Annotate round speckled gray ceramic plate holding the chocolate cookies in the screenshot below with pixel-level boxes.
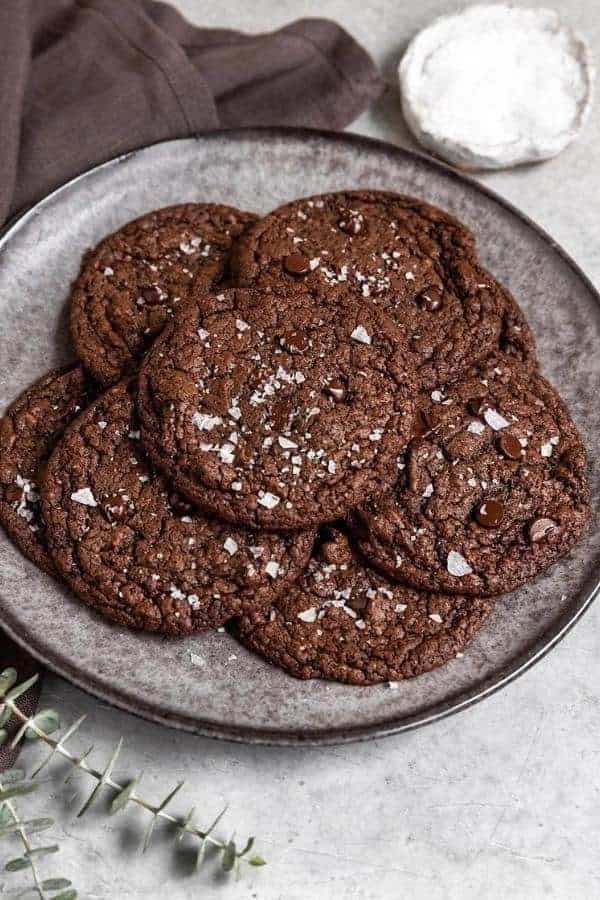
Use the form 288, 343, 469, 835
0, 129, 600, 744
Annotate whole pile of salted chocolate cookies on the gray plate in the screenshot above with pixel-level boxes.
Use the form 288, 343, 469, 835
0, 191, 589, 684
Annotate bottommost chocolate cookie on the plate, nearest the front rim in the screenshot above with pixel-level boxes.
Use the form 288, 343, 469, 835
233, 533, 493, 684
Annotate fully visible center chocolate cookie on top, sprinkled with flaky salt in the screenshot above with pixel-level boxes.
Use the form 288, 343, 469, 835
139, 288, 414, 529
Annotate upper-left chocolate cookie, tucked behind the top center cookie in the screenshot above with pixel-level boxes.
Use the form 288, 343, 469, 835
71, 203, 256, 385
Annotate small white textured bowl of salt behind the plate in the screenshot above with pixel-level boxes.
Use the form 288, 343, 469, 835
399, 5, 594, 169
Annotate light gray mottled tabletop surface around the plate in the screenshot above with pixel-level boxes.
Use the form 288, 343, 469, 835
8, 0, 600, 900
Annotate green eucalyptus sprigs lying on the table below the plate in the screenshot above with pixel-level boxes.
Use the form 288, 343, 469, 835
0, 669, 265, 888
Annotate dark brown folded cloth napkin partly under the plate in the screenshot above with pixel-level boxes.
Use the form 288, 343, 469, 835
0, 0, 383, 771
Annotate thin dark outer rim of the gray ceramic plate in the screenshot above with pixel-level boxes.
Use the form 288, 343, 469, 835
0, 126, 600, 747
